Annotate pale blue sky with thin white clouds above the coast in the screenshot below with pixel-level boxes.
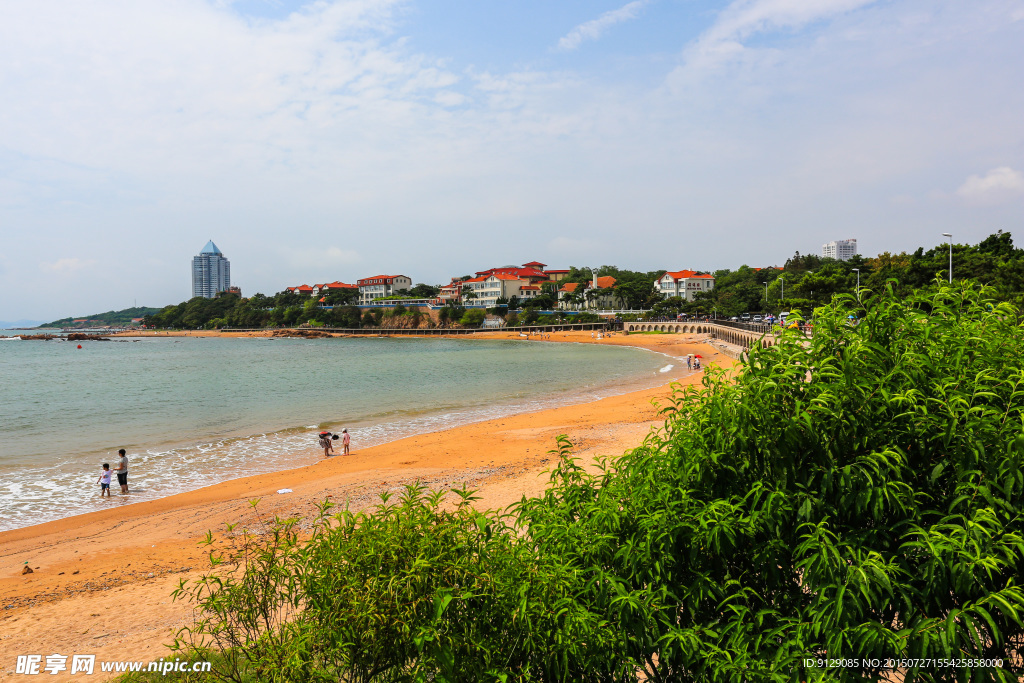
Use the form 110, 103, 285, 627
0, 0, 1024, 321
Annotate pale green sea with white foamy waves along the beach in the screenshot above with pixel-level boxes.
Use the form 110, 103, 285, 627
0, 332, 673, 529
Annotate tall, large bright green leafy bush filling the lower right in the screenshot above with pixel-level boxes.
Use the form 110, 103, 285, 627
519, 284, 1024, 681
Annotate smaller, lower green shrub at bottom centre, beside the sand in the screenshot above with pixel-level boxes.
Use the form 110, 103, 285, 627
175, 486, 610, 682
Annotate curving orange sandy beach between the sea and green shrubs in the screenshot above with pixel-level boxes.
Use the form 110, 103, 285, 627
0, 332, 734, 681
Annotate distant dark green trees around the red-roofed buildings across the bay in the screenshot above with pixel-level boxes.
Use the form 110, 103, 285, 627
143, 230, 1024, 329
